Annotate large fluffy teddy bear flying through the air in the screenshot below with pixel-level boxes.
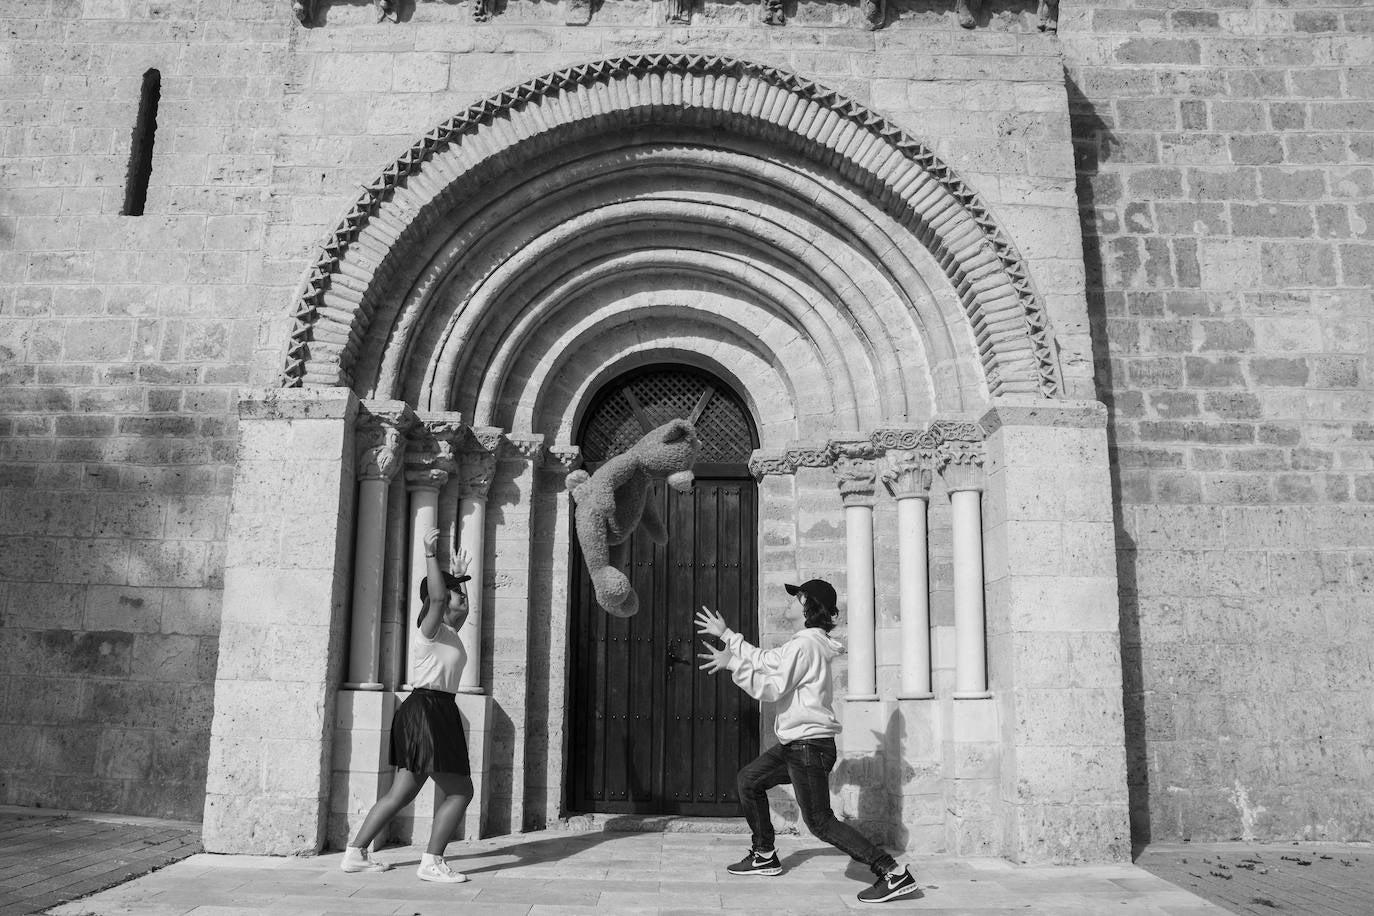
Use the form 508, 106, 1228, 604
566, 420, 701, 617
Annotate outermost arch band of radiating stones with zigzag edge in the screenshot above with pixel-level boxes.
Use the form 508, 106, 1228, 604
280, 54, 1062, 397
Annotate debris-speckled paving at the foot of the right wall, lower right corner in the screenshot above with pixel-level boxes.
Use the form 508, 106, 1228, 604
1136, 842, 1374, 916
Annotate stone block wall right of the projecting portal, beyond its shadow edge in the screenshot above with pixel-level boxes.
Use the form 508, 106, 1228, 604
1061, 0, 1374, 840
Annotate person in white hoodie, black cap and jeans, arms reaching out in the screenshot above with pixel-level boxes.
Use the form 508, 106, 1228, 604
697, 580, 919, 904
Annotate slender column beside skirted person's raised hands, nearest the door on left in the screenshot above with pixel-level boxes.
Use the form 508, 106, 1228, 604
458, 427, 502, 694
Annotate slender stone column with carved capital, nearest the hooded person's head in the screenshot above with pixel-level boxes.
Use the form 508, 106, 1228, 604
834, 449, 878, 702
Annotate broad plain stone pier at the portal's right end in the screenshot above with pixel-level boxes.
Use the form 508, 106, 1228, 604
981, 398, 1131, 862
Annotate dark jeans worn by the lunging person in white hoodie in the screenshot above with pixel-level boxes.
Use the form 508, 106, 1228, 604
738, 737, 897, 878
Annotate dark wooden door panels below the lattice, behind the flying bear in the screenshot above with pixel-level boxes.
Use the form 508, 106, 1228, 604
567, 365, 758, 816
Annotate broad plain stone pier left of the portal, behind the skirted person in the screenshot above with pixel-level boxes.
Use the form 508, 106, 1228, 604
202, 389, 359, 856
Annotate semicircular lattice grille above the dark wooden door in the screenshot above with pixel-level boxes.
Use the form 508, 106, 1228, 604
583, 369, 754, 464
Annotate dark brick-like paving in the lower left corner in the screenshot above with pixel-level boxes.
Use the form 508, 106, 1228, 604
0, 806, 201, 916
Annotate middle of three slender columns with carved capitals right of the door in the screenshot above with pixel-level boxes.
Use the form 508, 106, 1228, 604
882, 449, 934, 700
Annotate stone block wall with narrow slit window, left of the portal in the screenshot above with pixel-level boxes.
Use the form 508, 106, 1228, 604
0, 0, 294, 818
